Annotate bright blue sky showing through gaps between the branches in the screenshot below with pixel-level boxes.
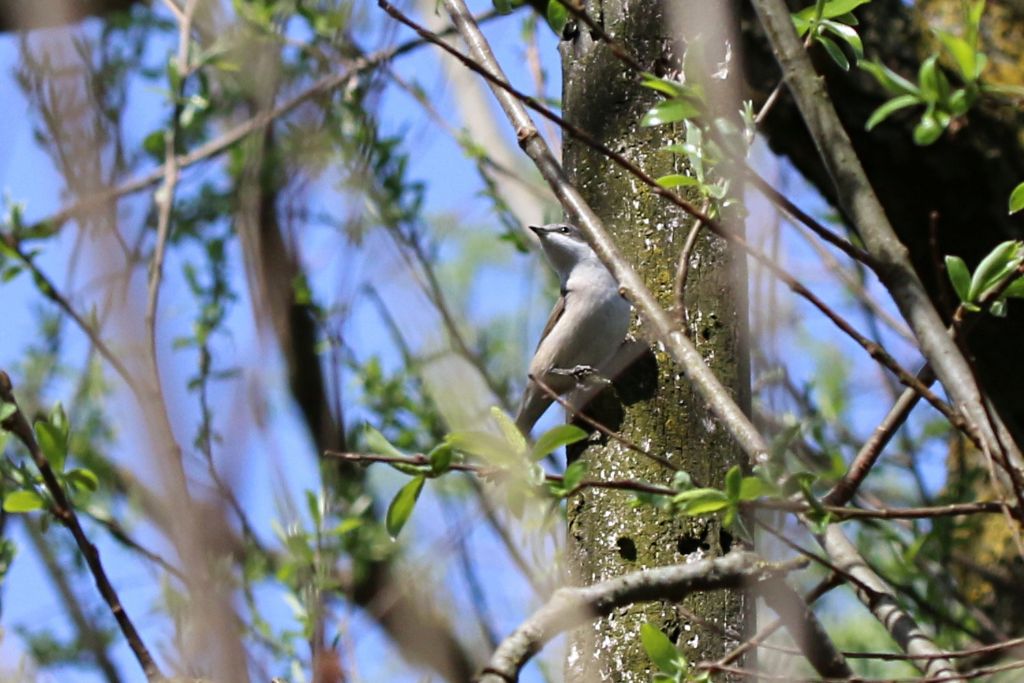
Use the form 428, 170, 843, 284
0, 3, 558, 681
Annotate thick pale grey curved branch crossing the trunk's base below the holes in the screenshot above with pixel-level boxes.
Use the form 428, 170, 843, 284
478, 551, 803, 683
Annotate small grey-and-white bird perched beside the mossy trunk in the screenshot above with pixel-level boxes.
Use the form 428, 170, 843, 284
515, 223, 632, 436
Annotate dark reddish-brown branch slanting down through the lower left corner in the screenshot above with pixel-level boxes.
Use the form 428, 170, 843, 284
0, 370, 164, 681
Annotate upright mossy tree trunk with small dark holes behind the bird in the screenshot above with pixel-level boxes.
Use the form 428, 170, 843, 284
561, 0, 753, 681
